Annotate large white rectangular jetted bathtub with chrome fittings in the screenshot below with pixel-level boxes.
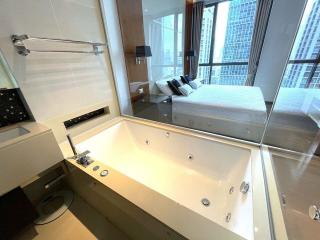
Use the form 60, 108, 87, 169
65, 119, 269, 239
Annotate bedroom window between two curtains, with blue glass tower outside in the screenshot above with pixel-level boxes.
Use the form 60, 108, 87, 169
198, 0, 256, 85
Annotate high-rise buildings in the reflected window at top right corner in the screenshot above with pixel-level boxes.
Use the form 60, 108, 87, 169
281, 1, 320, 88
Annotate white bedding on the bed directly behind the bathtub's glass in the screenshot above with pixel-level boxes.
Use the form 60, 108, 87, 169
172, 85, 267, 125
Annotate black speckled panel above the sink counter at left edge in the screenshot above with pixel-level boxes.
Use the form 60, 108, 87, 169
0, 89, 30, 128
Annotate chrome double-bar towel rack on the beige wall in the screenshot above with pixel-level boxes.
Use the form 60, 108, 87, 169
11, 34, 107, 56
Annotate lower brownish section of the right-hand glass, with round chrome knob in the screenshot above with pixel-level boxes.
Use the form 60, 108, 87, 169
270, 150, 320, 240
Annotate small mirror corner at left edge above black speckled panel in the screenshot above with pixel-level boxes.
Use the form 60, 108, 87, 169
0, 50, 18, 89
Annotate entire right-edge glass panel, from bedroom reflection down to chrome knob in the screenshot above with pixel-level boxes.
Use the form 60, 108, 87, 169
263, 0, 320, 240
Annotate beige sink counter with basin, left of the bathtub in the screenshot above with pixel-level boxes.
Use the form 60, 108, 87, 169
0, 122, 63, 196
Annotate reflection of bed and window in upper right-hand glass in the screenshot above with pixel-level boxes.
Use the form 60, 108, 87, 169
264, 0, 320, 154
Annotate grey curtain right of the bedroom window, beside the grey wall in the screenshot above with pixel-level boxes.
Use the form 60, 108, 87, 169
245, 0, 273, 86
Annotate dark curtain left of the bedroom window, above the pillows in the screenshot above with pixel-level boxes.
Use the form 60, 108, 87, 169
189, 2, 204, 79
